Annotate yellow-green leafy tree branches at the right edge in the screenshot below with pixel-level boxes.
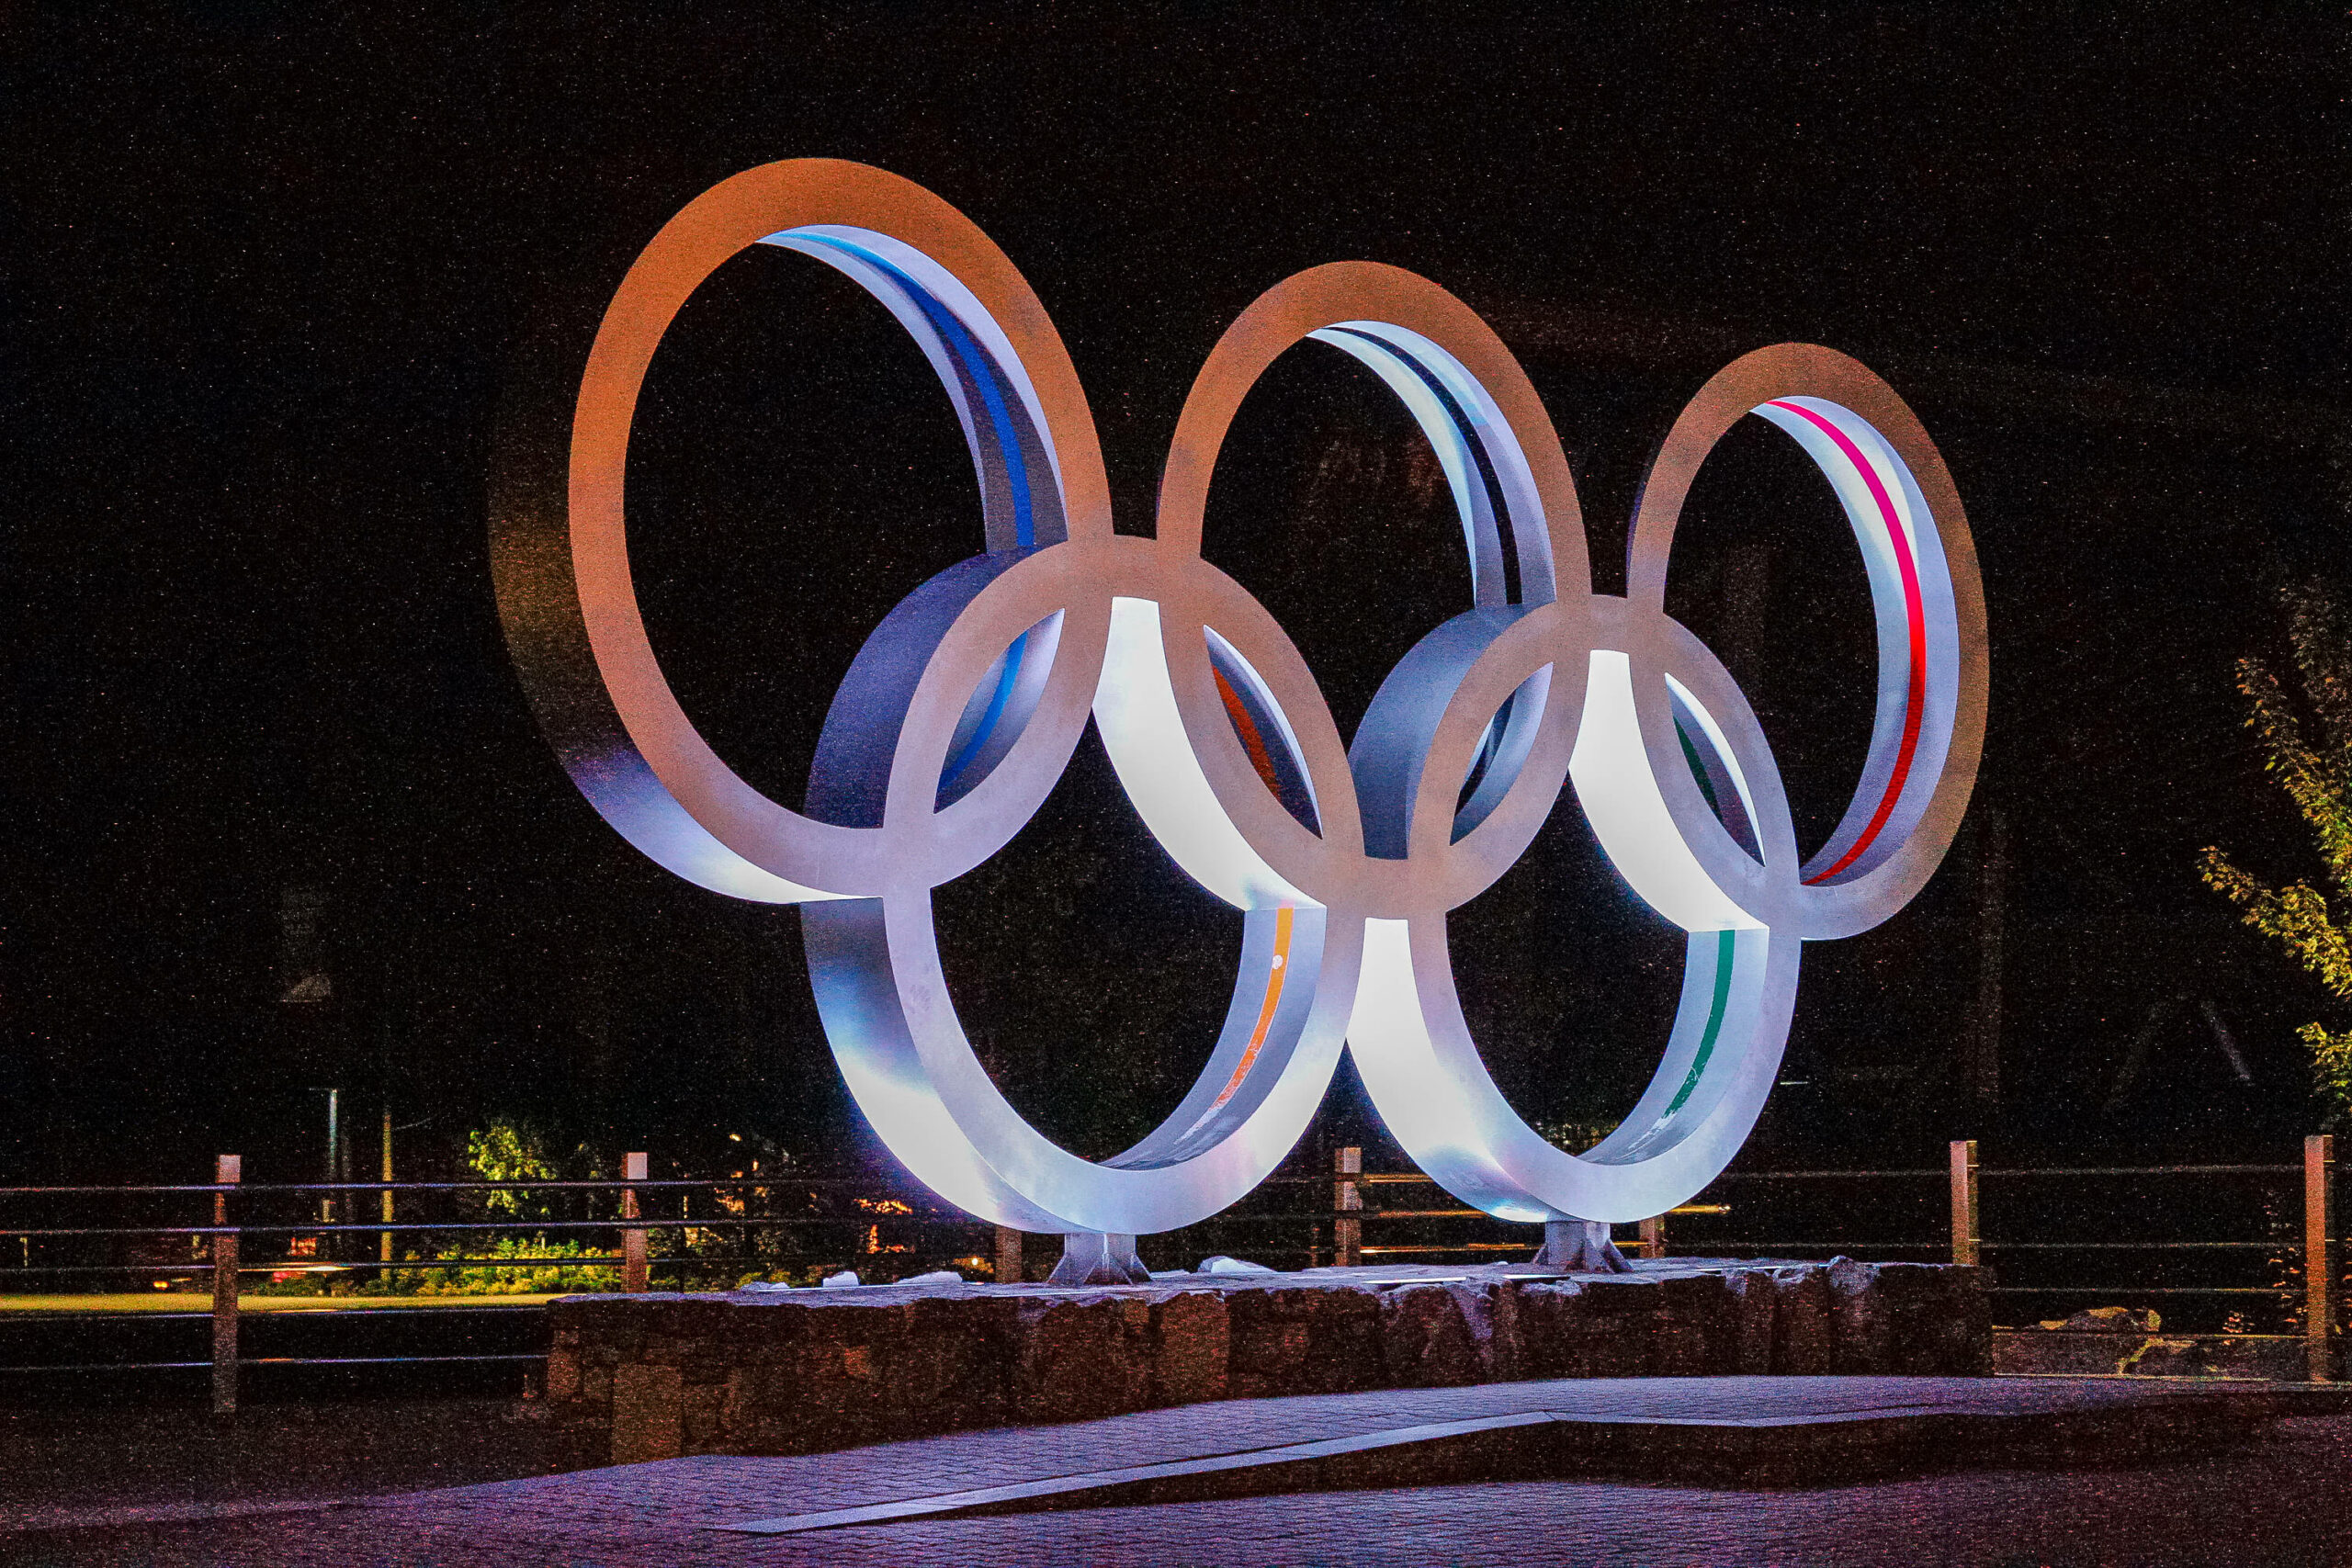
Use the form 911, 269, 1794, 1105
2199, 583, 2352, 1123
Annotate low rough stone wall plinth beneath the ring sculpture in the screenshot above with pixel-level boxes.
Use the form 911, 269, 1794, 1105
546, 1258, 1992, 1464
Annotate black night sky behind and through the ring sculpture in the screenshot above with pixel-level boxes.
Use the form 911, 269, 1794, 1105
0, 3, 2352, 1178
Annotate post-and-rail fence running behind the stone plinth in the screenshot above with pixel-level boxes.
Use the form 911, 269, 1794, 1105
0, 1138, 2340, 1413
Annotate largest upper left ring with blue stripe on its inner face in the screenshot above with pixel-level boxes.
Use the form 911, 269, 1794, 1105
494, 160, 1110, 903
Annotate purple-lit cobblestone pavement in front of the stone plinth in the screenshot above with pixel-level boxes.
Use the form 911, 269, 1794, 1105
18, 1380, 2352, 1568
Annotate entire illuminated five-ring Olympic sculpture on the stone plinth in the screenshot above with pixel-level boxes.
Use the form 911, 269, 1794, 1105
494, 160, 1987, 1269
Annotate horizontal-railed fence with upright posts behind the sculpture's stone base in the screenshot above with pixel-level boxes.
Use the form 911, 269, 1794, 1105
0, 1138, 2343, 1411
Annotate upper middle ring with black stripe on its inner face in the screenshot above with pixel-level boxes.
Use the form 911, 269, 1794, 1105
1138, 264, 1592, 917
